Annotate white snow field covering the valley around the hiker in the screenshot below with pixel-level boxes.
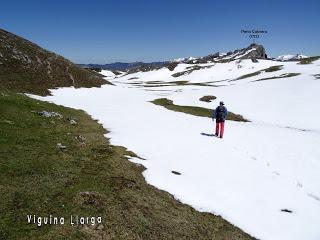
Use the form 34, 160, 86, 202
33, 57, 320, 240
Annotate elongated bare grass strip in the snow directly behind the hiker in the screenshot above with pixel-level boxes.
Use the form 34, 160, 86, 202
151, 98, 249, 122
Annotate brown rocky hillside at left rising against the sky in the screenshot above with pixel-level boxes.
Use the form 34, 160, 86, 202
0, 29, 108, 95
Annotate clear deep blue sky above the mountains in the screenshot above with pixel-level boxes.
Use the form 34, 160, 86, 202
0, 0, 320, 63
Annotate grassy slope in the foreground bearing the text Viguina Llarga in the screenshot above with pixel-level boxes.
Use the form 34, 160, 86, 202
0, 92, 252, 240
